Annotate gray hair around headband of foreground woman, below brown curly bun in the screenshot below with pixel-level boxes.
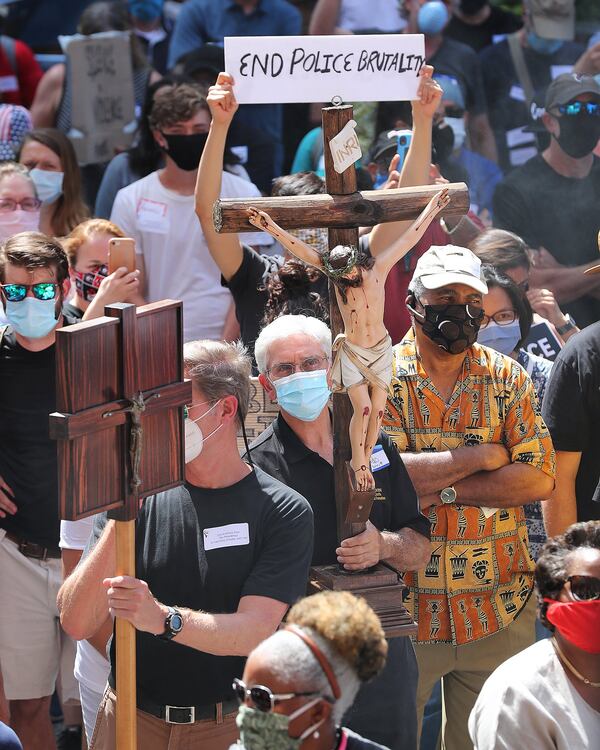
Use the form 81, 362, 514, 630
253, 627, 360, 725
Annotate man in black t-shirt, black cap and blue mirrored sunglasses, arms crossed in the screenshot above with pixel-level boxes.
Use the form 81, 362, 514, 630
494, 73, 600, 328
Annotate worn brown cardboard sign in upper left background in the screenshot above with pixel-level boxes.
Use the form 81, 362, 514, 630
59, 31, 136, 164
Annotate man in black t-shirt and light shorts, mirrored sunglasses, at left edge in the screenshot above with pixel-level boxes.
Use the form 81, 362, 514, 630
0, 232, 78, 750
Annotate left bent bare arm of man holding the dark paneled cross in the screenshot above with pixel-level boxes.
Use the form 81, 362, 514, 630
56, 521, 116, 641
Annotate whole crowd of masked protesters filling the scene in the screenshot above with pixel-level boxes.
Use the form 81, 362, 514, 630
0, 0, 600, 750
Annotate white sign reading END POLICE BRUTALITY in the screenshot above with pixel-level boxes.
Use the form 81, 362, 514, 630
225, 34, 425, 104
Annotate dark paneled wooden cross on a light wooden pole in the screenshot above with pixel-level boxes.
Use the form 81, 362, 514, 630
50, 300, 192, 750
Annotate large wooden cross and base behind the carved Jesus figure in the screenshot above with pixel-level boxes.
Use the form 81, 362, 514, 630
214, 105, 469, 637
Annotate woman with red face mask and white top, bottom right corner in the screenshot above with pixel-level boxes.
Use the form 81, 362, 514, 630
469, 521, 600, 750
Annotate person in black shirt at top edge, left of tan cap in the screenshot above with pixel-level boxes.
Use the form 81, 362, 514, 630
444, 0, 523, 52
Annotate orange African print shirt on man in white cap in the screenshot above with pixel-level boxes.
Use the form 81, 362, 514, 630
384, 331, 555, 645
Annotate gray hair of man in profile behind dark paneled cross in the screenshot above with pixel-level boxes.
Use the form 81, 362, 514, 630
183, 340, 252, 425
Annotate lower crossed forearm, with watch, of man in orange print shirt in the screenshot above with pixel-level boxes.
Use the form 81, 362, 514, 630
454, 462, 554, 508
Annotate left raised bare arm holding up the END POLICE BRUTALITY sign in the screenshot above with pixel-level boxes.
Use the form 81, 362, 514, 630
195, 73, 244, 281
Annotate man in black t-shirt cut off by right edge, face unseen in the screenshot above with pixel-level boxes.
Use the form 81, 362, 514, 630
542, 322, 600, 536
